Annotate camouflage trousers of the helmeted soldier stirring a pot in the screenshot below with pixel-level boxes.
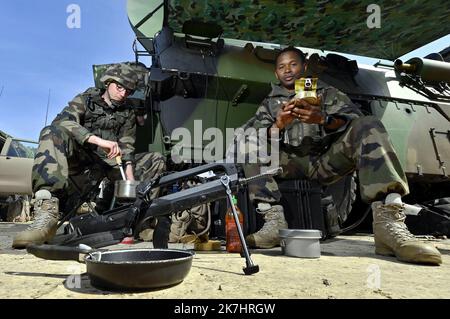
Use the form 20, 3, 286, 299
32, 125, 165, 202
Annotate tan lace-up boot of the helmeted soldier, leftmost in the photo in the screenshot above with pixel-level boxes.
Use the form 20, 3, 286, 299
12, 190, 59, 249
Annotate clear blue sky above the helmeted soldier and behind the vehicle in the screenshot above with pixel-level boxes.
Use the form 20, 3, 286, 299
0, 0, 450, 140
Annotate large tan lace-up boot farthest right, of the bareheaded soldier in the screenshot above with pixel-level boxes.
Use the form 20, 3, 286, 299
372, 194, 442, 265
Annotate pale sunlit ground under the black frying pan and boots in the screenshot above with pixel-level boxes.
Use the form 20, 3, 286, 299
0, 223, 450, 299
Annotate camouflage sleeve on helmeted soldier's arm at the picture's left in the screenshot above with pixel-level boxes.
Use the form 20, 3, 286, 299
52, 94, 93, 145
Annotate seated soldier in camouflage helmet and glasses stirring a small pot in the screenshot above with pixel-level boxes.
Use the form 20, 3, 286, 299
13, 64, 165, 248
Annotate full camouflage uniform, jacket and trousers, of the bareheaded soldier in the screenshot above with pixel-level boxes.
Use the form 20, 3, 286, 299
237, 81, 409, 203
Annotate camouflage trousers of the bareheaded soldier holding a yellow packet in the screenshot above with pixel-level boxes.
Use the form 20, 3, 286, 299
243, 116, 409, 203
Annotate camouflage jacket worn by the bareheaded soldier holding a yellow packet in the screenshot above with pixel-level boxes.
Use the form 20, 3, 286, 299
243, 80, 362, 156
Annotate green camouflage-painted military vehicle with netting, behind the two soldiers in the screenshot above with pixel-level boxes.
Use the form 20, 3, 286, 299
99, 0, 450, 232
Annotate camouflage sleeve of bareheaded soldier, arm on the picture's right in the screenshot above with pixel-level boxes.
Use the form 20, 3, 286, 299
322, 87, 363, 133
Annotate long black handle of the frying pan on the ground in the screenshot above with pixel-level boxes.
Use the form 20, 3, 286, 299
27, 244, 93, 263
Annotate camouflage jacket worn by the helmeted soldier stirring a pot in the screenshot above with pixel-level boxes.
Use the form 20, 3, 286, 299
52, 88, 136, 161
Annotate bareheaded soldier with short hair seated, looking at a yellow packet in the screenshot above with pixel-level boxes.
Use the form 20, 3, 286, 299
237, 47, 441, 264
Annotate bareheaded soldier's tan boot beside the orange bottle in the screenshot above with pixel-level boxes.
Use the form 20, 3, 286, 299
245, 203, 288, 248
